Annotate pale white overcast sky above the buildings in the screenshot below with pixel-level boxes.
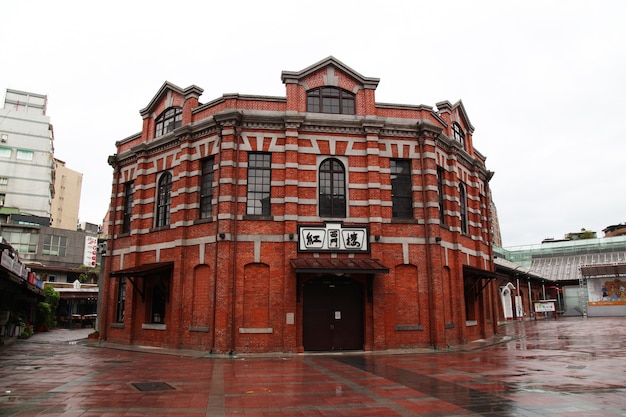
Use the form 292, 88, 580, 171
0, 0, 626, 247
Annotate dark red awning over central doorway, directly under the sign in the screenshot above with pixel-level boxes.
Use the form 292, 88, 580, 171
290, 258, 389, 274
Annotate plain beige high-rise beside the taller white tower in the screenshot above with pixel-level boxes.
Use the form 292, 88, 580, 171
51, 158, 83, 230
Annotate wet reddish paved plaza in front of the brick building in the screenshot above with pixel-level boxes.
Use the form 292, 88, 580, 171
0, 318, 626, 417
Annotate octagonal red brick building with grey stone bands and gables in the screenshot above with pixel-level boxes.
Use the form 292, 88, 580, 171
101, 57, 502, 353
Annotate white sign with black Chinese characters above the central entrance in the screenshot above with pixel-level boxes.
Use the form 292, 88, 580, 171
298, 223, 369, 252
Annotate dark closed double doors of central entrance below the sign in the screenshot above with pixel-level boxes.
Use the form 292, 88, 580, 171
302, 276, 364, 351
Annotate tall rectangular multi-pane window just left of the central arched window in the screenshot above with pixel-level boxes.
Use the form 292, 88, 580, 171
246, 152, 272, 216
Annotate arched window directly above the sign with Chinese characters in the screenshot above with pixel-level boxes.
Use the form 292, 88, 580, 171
319, 158, 346, 217
